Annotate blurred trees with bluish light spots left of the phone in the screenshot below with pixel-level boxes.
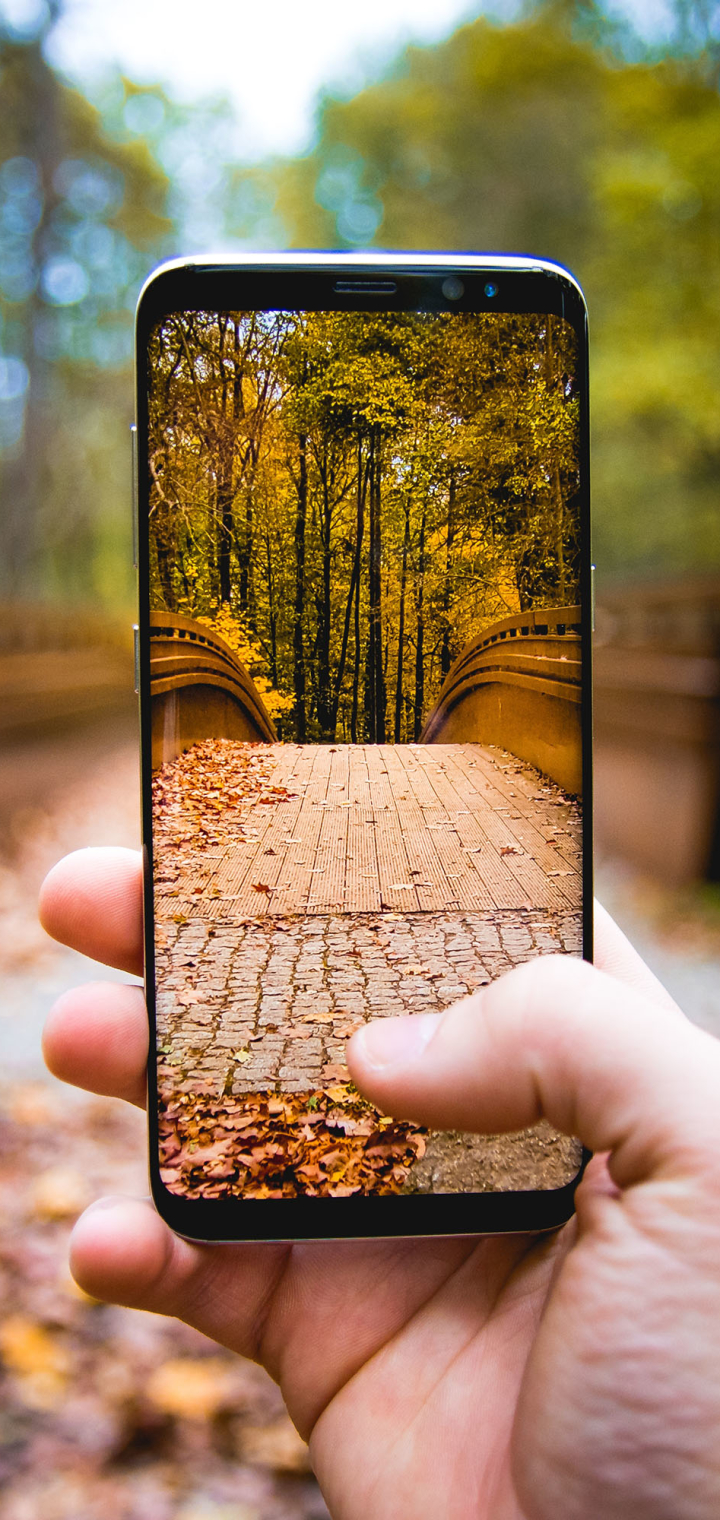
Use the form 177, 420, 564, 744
0, 19, 170, 598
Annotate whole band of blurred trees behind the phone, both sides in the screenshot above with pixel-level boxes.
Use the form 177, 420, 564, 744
0, 0, 720, 610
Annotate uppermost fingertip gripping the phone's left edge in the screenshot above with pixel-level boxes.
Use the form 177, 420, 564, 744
39, 845, 143, 976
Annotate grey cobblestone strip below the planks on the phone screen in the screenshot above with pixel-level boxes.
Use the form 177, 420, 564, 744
158, 910, 580, 1096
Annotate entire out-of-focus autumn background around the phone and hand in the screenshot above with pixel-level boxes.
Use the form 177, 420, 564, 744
0, 0, 720, 1520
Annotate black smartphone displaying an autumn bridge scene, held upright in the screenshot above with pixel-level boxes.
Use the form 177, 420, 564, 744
137, 254, 592, 1240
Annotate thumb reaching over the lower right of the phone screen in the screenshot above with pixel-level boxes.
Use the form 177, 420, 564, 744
348, 956, 720, 1187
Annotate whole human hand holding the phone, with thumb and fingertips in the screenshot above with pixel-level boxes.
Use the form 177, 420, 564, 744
41, 850, 720, 1520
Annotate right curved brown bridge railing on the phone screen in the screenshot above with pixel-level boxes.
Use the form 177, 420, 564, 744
421, 606, 582, 795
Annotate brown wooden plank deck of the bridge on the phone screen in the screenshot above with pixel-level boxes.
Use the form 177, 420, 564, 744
158, 743, 582, 921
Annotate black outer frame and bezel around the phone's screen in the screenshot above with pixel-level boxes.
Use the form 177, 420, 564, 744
134, 252, 592, 1242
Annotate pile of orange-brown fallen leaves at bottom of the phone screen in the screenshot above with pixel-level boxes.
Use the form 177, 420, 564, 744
159, 1082, 427, 1198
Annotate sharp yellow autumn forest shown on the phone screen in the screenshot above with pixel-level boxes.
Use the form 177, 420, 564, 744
149, 312, 579, 743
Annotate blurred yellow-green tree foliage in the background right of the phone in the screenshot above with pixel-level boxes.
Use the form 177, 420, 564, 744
263, 6, 720, 576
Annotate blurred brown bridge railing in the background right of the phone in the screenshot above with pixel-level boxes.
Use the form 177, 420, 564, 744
594, 572, 720, 882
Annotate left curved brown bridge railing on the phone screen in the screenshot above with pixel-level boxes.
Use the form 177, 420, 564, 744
150, 613, 278, 769
